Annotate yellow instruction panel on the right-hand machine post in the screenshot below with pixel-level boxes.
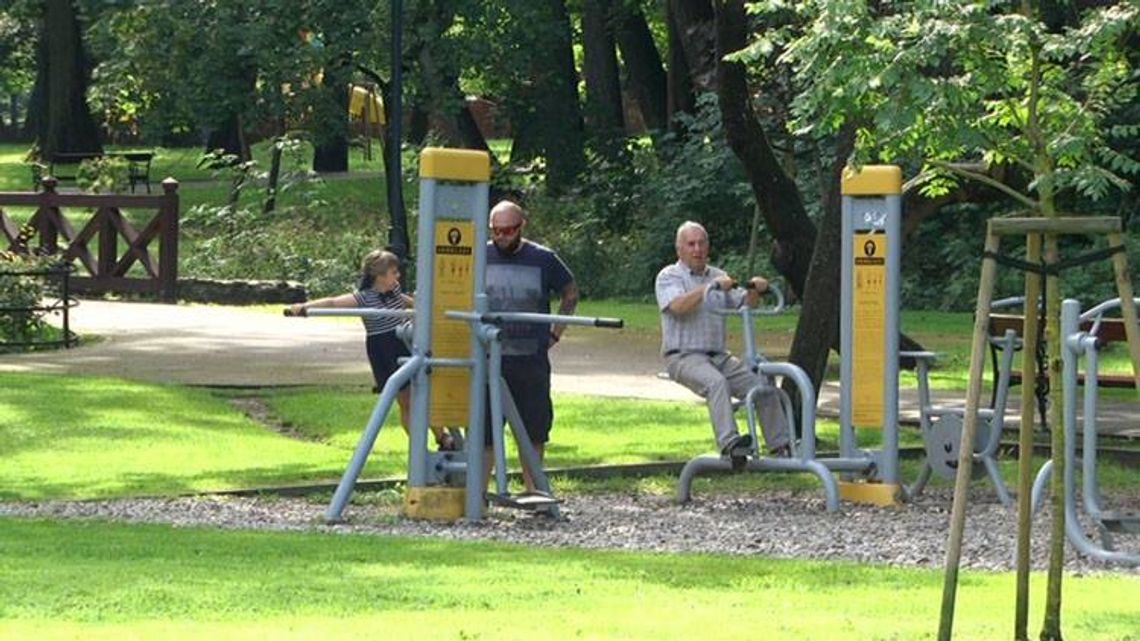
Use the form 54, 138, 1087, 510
852, 232, 887, 428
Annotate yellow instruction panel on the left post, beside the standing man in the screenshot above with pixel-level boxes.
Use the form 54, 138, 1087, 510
428, 220, 475, 427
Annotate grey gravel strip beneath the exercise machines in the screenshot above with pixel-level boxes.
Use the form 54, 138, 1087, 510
0, 489, 1140, 576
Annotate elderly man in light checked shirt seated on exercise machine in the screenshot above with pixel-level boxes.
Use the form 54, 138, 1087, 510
656, 221, 790, 457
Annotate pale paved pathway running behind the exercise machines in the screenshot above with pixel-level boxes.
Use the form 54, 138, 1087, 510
0, 300, 1140, 438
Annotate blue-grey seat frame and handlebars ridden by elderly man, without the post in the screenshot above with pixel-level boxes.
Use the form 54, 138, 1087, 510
677, 284, 839, 511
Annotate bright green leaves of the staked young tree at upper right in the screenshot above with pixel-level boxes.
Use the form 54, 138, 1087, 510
754, 0, 1140, 212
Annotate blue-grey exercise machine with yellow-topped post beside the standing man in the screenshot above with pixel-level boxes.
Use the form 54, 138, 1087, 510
289, 147, 622, 522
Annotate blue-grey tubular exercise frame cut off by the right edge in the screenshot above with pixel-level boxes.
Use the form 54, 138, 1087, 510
1033, 298, 1140, 566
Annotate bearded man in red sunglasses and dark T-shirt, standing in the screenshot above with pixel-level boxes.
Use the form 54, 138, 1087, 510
485, 201, 578, 493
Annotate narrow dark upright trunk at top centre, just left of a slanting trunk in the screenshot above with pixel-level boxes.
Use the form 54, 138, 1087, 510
581, 0, 625, 151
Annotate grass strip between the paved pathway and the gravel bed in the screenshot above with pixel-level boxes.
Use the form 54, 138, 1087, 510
0, 373, 1135, 500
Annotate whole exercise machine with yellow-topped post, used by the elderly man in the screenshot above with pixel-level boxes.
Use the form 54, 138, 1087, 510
677, 165, 975, 510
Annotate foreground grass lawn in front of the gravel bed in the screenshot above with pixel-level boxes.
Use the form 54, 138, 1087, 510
0, 518, 1140, 641
